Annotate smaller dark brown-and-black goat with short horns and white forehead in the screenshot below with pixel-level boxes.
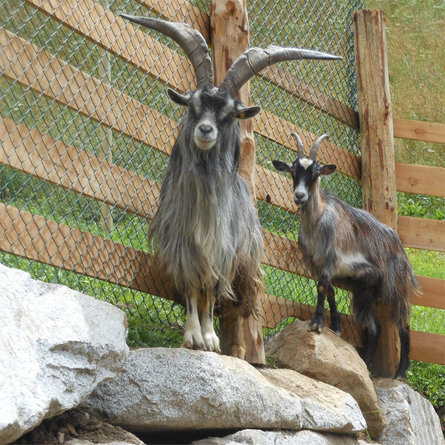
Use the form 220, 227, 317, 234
273, 133, 420, 378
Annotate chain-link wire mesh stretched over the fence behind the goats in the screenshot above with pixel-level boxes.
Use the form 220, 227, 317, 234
0, 0, 363, 345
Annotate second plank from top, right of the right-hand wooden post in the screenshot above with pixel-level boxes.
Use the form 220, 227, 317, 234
396, 162, 445, 196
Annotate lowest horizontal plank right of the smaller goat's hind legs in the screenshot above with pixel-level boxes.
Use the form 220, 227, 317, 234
410, 331, 445, 365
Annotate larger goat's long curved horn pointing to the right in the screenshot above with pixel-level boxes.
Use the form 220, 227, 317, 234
218, 45, 341, 97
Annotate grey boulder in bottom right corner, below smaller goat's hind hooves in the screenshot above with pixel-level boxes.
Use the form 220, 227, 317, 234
374, 379, 445, 445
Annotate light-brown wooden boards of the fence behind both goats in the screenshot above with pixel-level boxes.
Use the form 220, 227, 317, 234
0, 0, 445, 373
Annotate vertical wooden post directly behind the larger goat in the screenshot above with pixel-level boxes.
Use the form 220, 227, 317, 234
210, 0, 266, 364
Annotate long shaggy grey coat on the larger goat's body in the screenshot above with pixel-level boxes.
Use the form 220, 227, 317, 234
149, 91, 263, 316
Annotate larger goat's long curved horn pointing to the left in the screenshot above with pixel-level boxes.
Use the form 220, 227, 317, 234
119, 14, 215, 88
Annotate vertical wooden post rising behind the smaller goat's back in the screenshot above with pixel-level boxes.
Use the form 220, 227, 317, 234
354, 10, 400, 377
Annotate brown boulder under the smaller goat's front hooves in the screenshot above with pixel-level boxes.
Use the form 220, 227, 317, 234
266, 321, 384, 438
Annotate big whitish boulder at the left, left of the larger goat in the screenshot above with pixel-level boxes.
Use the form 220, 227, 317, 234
0, 265, 129, 444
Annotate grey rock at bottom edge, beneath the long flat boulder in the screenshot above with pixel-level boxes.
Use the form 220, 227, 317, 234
192, 430, 372, 445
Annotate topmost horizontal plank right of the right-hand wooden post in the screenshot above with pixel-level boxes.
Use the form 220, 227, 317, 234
393, 118, 445, 144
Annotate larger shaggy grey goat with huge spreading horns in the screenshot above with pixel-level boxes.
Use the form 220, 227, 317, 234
122, 14, 339, 358
